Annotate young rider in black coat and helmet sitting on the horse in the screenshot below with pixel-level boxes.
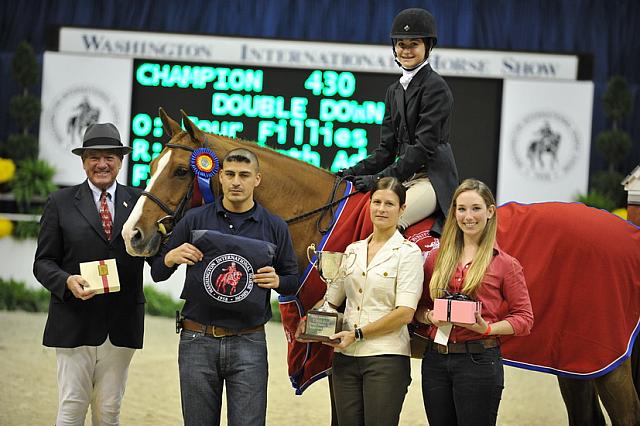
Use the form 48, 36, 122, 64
338, 8, 458, 233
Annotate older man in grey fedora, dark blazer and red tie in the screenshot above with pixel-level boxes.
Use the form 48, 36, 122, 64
33, 123, 145, 426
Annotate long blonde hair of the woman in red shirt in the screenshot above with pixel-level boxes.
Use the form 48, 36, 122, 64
429, 179, 498, 299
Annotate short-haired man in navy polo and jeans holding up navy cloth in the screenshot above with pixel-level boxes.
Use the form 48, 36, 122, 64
151, 149, 298, 426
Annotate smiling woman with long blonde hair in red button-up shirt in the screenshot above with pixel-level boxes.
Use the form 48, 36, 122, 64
416, 179, 533, 426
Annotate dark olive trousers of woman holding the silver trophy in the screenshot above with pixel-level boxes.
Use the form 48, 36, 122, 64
332, 353, 411, 426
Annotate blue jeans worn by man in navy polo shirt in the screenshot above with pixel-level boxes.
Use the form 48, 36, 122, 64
178, 330, 268, 426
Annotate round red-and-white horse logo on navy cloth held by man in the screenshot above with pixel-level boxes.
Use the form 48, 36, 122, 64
203, 254, 253, 303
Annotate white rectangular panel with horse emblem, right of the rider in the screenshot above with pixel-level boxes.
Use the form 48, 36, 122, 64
497, 80, 593, 204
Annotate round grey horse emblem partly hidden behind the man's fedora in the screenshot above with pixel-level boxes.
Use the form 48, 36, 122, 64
47, 86, 120, 149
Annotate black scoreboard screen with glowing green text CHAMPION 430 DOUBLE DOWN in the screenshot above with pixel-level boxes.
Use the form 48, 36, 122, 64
128, 59, 502, 188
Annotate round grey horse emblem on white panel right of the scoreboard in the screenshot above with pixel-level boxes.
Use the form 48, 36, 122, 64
511, 111, 583, 181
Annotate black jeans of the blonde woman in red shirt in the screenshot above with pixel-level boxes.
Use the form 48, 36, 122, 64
422, 348, 504, 426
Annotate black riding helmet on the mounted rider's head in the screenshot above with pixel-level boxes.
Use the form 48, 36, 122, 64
391, 7, 438, 68
